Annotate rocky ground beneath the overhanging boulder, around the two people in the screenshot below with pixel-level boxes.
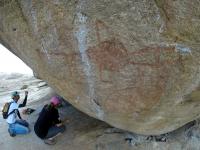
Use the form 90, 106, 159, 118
0, 74, 200, 150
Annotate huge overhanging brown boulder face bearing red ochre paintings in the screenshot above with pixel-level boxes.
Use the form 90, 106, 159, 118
0, 0, 200, 135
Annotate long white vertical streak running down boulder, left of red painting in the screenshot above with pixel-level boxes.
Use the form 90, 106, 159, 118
75, 0, 104, 120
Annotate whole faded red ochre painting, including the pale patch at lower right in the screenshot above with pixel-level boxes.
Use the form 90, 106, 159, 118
87, 21, 184, 113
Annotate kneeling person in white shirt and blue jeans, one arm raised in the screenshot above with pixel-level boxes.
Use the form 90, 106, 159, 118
6, 91, 30, 137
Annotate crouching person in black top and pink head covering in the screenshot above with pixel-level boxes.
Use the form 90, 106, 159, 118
34, 96, 65, 145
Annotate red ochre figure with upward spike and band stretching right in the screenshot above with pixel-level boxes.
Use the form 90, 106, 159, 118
87, 20, 181, 81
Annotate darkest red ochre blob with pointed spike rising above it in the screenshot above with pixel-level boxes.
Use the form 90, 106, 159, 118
87, 20, 128, 81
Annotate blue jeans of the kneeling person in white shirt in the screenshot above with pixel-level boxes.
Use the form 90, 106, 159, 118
8, 120, 30, 135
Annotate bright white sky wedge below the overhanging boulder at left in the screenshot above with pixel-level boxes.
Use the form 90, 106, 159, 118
0, 44, 33, 75
